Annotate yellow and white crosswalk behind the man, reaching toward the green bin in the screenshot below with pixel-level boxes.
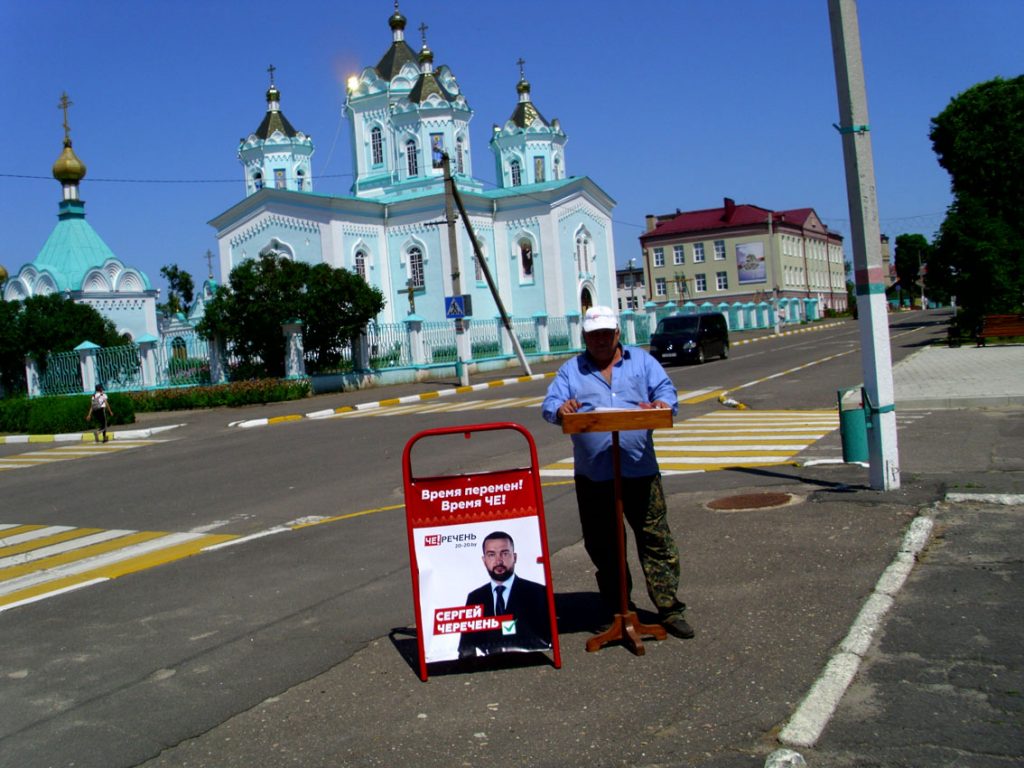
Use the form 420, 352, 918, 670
541, 411, 839, 477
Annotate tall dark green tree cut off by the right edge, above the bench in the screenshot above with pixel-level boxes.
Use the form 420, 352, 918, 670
926, 76, 1024, 326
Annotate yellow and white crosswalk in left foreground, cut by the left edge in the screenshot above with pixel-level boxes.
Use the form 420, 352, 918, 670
0, 523, 238, 611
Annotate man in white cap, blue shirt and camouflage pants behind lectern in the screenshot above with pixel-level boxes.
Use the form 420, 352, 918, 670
542, 306, 693, 638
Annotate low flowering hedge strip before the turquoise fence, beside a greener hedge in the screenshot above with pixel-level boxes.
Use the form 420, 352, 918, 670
128, 379, 312, 413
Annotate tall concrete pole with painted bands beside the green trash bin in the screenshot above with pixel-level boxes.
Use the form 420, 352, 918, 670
828, 0, 900, 490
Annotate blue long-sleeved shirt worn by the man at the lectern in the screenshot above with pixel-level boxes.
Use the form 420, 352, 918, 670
541, 347, 679, 481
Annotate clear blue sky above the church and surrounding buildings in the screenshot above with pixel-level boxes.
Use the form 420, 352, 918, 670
0, 0, 1024, 296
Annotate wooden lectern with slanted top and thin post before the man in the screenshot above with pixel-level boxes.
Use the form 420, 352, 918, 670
562, 408, 672, 656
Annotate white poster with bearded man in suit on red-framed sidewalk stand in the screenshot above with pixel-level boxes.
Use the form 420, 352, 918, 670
412, 493, 552, 664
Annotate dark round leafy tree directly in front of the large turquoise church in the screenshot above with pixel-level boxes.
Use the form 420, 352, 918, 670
199, 254, 384, 376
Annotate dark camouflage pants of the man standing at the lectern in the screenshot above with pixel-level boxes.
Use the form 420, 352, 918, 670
575, 475, 686, 618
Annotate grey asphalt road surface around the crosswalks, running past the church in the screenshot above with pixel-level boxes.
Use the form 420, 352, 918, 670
0, 313, 941, 768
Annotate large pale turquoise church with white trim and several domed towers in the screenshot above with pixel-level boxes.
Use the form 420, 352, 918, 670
210, 9, 615, 323
